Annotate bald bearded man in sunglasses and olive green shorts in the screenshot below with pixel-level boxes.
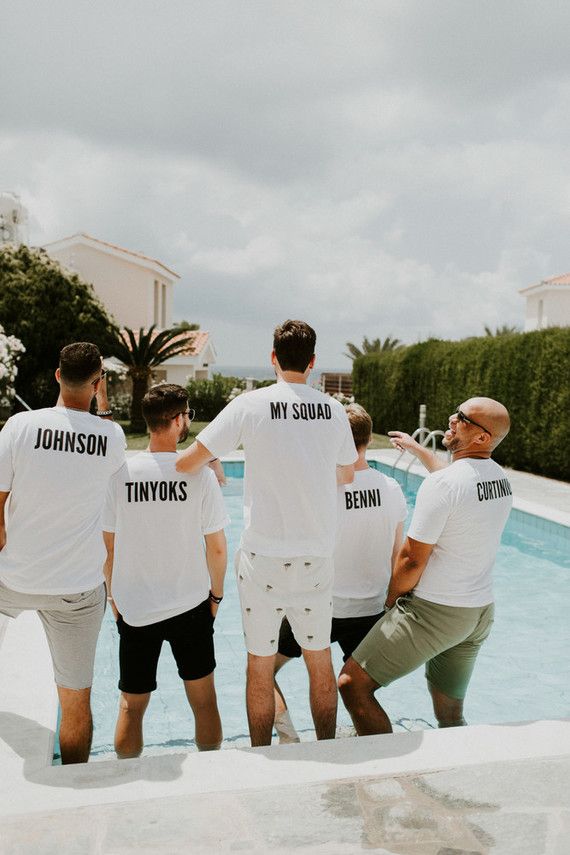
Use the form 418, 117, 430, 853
339, 398, 512, 736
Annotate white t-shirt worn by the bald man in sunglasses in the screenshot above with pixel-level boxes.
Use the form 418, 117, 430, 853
408, 458, 513, 608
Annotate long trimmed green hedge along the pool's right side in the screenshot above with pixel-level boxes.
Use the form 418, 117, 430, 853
353, 328, 570, 481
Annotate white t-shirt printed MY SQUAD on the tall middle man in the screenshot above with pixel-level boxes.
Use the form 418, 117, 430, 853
197, 380, 358, 558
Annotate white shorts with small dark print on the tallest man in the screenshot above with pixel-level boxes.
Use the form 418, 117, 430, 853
235, 549, 334, 656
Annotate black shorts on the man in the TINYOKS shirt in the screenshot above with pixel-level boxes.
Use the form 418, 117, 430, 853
117, 600, 216, 695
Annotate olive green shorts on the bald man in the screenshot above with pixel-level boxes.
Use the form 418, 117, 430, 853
352, 594, 494, 700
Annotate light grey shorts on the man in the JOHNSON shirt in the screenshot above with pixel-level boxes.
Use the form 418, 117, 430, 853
0, 582, 106, 689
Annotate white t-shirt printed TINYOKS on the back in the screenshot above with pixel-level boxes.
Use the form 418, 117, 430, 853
103, 451, 229, 626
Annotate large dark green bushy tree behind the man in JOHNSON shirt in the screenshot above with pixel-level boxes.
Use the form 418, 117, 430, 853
0, 245, 116, 408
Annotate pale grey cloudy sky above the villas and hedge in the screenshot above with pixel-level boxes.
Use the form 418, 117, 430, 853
0, 0, 570, 368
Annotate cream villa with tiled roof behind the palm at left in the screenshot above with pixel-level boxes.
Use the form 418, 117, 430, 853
44, 232, 216, 385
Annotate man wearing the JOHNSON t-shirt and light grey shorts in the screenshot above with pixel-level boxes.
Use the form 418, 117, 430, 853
0, 342, 125, 763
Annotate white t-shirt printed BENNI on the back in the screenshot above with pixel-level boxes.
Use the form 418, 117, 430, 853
333, 468, 408, 618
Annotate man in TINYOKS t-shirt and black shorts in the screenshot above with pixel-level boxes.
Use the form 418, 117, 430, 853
103, 383, 229, 759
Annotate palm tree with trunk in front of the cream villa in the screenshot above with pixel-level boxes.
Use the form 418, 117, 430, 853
114, 324, 194, 433
